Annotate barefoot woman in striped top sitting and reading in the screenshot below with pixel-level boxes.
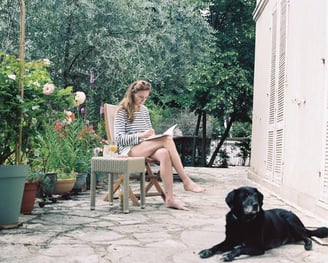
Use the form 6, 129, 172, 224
114, 80, 205, 210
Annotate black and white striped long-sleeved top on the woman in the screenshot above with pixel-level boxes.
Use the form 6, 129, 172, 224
114, 105, 152, 154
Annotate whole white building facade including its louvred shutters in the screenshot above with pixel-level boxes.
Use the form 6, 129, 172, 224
249, 0, 328, 219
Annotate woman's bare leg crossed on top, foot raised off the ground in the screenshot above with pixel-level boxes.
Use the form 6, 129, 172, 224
129, 136, 205, 193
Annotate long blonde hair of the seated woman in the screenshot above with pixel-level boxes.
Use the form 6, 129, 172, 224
119, 80, 151, 122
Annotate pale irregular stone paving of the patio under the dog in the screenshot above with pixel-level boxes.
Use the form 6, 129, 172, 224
0, 167, 328, 263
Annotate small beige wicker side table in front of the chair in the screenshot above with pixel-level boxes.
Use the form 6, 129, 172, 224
90, 157, 145, 213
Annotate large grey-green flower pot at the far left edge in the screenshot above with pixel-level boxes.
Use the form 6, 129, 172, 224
0, 165, 29, 225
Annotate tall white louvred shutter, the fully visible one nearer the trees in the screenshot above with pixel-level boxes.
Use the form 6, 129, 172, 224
265, 0, 288, 185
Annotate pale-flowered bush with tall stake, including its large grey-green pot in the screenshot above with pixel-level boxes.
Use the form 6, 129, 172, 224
0, 0, 74, 225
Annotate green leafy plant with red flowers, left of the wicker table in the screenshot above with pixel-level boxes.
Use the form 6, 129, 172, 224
31, 112, 99, 178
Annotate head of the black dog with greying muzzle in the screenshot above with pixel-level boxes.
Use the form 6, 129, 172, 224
225, 186, 263, 222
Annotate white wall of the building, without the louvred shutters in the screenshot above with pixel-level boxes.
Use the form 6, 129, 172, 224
250, 0, 328, 218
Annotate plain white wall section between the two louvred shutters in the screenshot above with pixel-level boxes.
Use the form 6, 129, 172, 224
284, 0, 326, 198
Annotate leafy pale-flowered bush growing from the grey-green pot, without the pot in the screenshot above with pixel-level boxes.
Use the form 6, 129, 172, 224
0, 53, 74, 164
